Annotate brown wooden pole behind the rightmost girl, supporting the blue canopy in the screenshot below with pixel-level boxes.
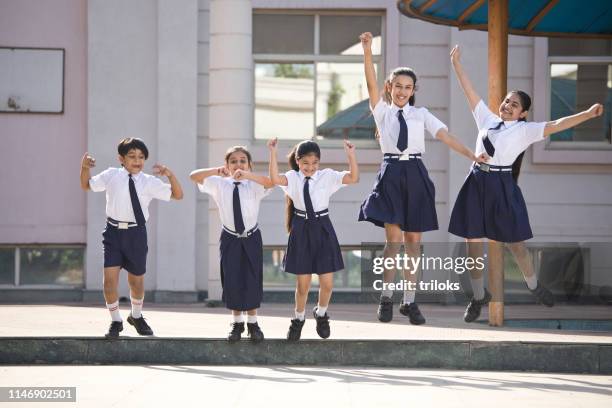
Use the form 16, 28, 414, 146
488, 0, 508, 326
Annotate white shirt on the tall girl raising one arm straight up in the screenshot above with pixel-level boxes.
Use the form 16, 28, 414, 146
370, 98, 448, 154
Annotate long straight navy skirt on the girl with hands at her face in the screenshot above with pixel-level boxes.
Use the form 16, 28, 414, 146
219, 230, 263, 311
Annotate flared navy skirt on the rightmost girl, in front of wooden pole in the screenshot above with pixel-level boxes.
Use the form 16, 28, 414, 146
448, 167, 533, 242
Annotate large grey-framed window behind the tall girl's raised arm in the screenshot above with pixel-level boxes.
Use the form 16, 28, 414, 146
253, 11, 383, 140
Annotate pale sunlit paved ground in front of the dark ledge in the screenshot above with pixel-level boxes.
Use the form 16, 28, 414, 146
0, 366, 612, 408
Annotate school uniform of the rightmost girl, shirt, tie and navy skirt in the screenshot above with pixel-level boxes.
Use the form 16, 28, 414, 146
448, 100, 546, 242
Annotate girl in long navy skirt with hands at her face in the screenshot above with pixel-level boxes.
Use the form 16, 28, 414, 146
191, 146, 274, 342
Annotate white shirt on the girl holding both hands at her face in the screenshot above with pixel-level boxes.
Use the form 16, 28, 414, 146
198, 176, 272, 231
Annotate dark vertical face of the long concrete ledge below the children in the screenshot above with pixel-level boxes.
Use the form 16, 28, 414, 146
0, 337, 612, 375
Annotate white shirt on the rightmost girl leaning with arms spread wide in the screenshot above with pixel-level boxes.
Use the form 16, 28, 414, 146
472, 99, 546, 166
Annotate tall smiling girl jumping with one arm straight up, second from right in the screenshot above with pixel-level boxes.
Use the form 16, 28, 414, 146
359, 33, 484, 324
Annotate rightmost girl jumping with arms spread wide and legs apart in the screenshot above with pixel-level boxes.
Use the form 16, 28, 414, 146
448, 46, 603, 322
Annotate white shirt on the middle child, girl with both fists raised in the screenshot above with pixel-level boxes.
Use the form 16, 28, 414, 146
280, 169, 349, 212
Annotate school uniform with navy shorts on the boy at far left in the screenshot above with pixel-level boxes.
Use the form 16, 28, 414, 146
89, 167, 172, 275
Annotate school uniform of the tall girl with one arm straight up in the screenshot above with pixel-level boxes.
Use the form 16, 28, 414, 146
359, 98, 447, 232
